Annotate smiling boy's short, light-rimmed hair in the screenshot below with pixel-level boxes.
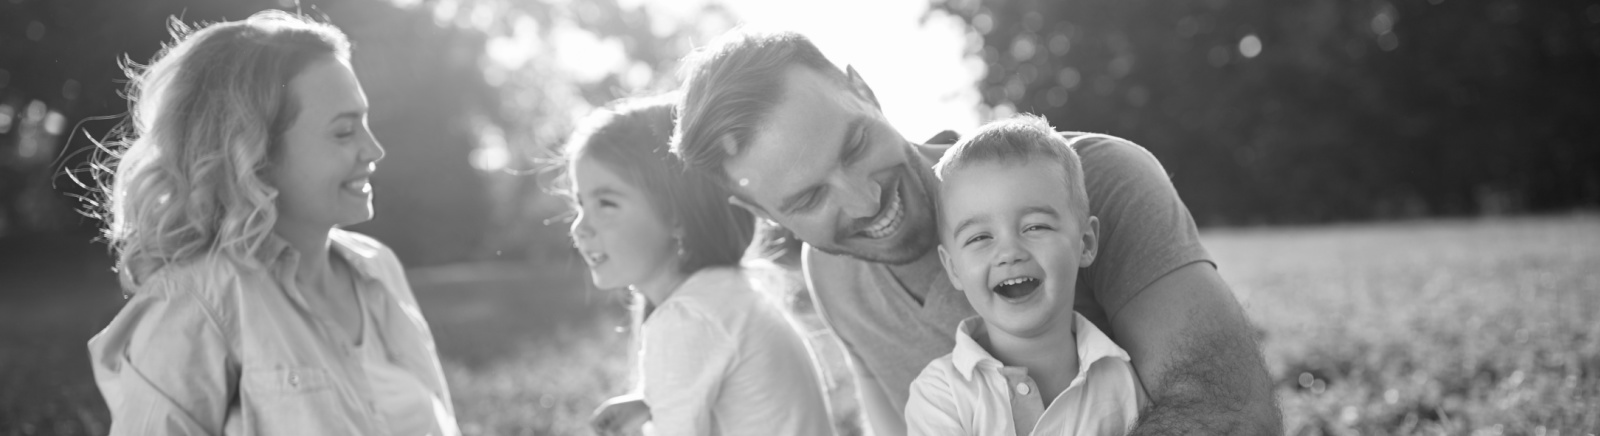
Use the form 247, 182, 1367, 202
933, 114, 1090, 223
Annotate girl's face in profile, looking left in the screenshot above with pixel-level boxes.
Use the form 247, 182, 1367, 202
570, 155, 678, 289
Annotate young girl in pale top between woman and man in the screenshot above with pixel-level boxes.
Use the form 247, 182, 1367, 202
565, 99, 832, 434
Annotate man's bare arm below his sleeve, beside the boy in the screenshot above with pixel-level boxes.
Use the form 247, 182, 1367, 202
1110, 263, 1283, 434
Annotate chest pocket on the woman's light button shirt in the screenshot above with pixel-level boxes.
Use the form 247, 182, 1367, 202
240, 365, 360, 434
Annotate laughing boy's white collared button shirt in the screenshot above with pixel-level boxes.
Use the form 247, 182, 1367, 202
906, 313, 1146, 436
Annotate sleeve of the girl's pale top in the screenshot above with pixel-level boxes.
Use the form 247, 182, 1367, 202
642, 301, 736, 436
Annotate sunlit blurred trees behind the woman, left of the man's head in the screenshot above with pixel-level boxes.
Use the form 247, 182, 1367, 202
0, 0, 731, 263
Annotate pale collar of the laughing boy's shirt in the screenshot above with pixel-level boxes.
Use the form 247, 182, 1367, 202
950, 311, 1131, 380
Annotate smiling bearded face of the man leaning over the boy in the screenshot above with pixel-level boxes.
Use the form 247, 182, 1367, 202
723, 66, 939, 263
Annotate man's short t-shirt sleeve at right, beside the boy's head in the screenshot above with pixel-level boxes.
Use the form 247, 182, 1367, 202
1067, 135, 1211, 317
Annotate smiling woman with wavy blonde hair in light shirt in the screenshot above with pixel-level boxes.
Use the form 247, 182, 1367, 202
90, 11, 459, 434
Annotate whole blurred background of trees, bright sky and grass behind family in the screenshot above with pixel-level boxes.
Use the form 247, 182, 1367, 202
0, 0, 1600, 434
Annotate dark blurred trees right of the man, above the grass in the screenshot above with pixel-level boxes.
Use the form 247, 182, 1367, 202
933, 0, 1600, 224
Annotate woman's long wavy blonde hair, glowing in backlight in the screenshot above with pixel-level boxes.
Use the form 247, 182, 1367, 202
90, 11, 350, 292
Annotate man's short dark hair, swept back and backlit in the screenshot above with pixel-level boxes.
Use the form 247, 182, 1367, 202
672, 27, 845, 181
